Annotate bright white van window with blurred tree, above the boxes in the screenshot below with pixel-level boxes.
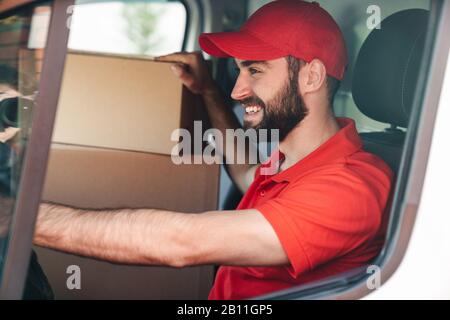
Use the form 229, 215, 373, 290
69, 0, 187, 56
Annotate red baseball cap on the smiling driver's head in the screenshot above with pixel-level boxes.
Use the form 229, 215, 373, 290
199, 0, 348, 80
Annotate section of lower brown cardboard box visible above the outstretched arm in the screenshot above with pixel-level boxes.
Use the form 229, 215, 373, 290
43, 144, 220, 213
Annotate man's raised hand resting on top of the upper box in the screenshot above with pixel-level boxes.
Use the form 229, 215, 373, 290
155, 52, 217, 95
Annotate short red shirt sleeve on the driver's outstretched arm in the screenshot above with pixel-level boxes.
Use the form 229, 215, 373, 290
255, 171, 389, 278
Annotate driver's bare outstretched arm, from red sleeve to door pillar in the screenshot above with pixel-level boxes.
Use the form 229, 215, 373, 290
34, 204, 288, 267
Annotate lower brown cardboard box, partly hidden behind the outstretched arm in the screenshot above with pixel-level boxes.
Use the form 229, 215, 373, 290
36, 145, 219, 299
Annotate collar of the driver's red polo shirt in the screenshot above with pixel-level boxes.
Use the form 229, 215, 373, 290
260, 118, 362, 182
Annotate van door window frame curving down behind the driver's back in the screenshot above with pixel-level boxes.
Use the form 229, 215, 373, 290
255, 0, 450, 300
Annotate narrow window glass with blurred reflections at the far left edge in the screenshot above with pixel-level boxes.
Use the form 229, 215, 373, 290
0, 5, 51, 281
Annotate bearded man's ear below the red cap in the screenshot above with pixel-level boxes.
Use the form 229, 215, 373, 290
298, 59, 327, 95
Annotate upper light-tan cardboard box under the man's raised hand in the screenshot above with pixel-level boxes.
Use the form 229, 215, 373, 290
53, 52, 209, 155
